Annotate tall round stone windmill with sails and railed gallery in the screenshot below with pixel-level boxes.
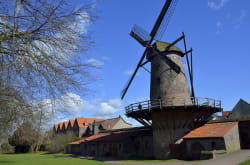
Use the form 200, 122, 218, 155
121, 0, 222, 159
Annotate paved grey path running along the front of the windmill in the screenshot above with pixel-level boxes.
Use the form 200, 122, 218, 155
105, 150, 250, 165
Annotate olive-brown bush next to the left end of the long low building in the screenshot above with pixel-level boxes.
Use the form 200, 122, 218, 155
47, 133, 76, 153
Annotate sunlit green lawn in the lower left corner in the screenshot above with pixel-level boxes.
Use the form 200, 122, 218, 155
0, 153, 113, 165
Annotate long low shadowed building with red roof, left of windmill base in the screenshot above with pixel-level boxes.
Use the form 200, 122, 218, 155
66, 127, 154, 158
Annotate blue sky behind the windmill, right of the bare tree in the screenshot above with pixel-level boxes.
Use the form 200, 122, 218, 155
49, 0, 250, 126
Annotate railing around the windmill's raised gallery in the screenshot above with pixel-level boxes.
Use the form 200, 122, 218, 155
125, 97, 221, 113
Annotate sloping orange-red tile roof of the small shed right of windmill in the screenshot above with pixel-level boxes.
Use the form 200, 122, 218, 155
184, 122, 238, 139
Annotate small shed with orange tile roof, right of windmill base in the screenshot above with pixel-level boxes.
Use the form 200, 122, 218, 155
183, 122, 240, 159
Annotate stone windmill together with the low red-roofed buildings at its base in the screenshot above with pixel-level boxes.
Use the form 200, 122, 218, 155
67, 0, 249, 159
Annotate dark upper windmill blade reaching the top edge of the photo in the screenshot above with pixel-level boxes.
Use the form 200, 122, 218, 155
150, 0, 175, 40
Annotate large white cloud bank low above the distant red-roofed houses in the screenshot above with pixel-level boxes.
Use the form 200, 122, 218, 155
34, 93, 124, 125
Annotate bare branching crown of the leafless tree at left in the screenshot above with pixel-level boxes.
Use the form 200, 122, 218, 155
0, 0, 95, 136
